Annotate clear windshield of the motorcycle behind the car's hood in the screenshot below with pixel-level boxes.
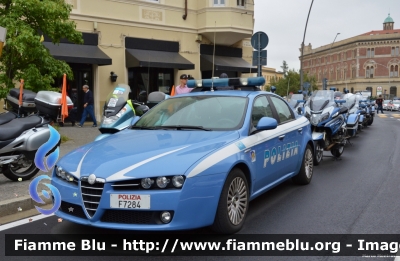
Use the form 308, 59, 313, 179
104, 84, 131, 116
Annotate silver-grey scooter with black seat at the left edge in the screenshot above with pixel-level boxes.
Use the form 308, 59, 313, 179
0, 113, 57, 181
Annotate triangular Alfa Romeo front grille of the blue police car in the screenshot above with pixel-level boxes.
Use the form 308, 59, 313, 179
81, 180, 104, 217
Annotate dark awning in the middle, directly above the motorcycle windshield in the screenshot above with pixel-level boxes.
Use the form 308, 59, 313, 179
125, 49, 194, 70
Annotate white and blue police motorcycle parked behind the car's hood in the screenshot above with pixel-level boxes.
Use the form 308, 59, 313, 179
95, 84, 149, 141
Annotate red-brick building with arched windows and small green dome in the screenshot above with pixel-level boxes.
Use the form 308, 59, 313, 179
300, 14, 400, 98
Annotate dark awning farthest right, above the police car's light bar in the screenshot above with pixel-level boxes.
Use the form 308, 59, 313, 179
200, 54, 257, 73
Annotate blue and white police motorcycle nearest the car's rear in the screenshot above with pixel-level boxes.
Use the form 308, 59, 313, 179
304, 90, 348, 165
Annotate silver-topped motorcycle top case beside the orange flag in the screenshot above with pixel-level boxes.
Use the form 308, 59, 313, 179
35, 91, 74, 119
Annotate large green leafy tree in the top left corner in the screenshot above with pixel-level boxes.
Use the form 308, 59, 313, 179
0, 0, 83, 99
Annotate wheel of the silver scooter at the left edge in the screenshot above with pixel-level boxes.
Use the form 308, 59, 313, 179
3, 158, 39, 181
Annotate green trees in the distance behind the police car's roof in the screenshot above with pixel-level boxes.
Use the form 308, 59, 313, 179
266, 63, 318, 97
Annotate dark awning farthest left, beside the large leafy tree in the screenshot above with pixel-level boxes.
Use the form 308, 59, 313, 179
43, 42, 112, 65
